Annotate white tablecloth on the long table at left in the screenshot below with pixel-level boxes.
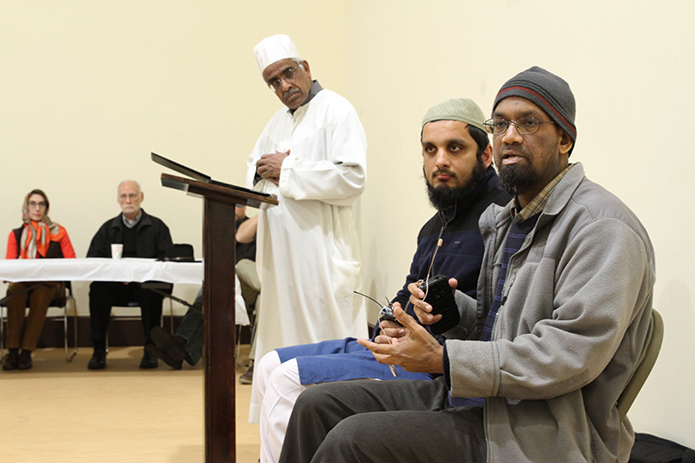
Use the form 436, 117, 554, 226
0, 258, 203, 284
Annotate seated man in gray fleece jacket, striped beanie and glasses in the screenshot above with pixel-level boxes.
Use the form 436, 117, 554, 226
280, 67, 655, 463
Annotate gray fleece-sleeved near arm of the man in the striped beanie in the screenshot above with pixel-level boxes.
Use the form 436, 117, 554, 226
446, 219, 654, 399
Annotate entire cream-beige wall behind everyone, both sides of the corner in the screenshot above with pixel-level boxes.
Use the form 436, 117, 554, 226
0, 0, 695, 446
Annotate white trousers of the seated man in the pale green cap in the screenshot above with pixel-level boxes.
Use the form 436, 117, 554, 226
253, 350, 310, 463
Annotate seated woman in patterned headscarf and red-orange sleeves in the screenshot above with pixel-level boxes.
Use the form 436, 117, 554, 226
2, 190, 75, 370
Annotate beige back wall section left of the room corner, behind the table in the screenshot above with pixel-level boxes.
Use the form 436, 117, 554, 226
0, 0, 345, 313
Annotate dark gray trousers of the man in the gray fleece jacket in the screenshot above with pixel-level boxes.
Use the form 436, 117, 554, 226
280, 377, 487, 463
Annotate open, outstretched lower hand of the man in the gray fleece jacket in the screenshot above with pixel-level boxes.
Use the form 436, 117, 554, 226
357, 307, 444, 373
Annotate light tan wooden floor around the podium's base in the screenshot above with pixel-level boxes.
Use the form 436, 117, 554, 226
0, 346, 260, 463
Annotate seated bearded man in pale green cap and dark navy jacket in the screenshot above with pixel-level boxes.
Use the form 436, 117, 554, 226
256, 98, 509, 463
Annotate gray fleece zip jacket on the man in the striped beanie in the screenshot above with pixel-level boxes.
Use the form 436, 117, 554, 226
445, 164, 655, 463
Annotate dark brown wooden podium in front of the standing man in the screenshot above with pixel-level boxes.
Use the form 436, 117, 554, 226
161, 173, 278, 463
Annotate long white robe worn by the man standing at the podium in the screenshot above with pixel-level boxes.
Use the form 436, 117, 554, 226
246, 89, 367, 422
